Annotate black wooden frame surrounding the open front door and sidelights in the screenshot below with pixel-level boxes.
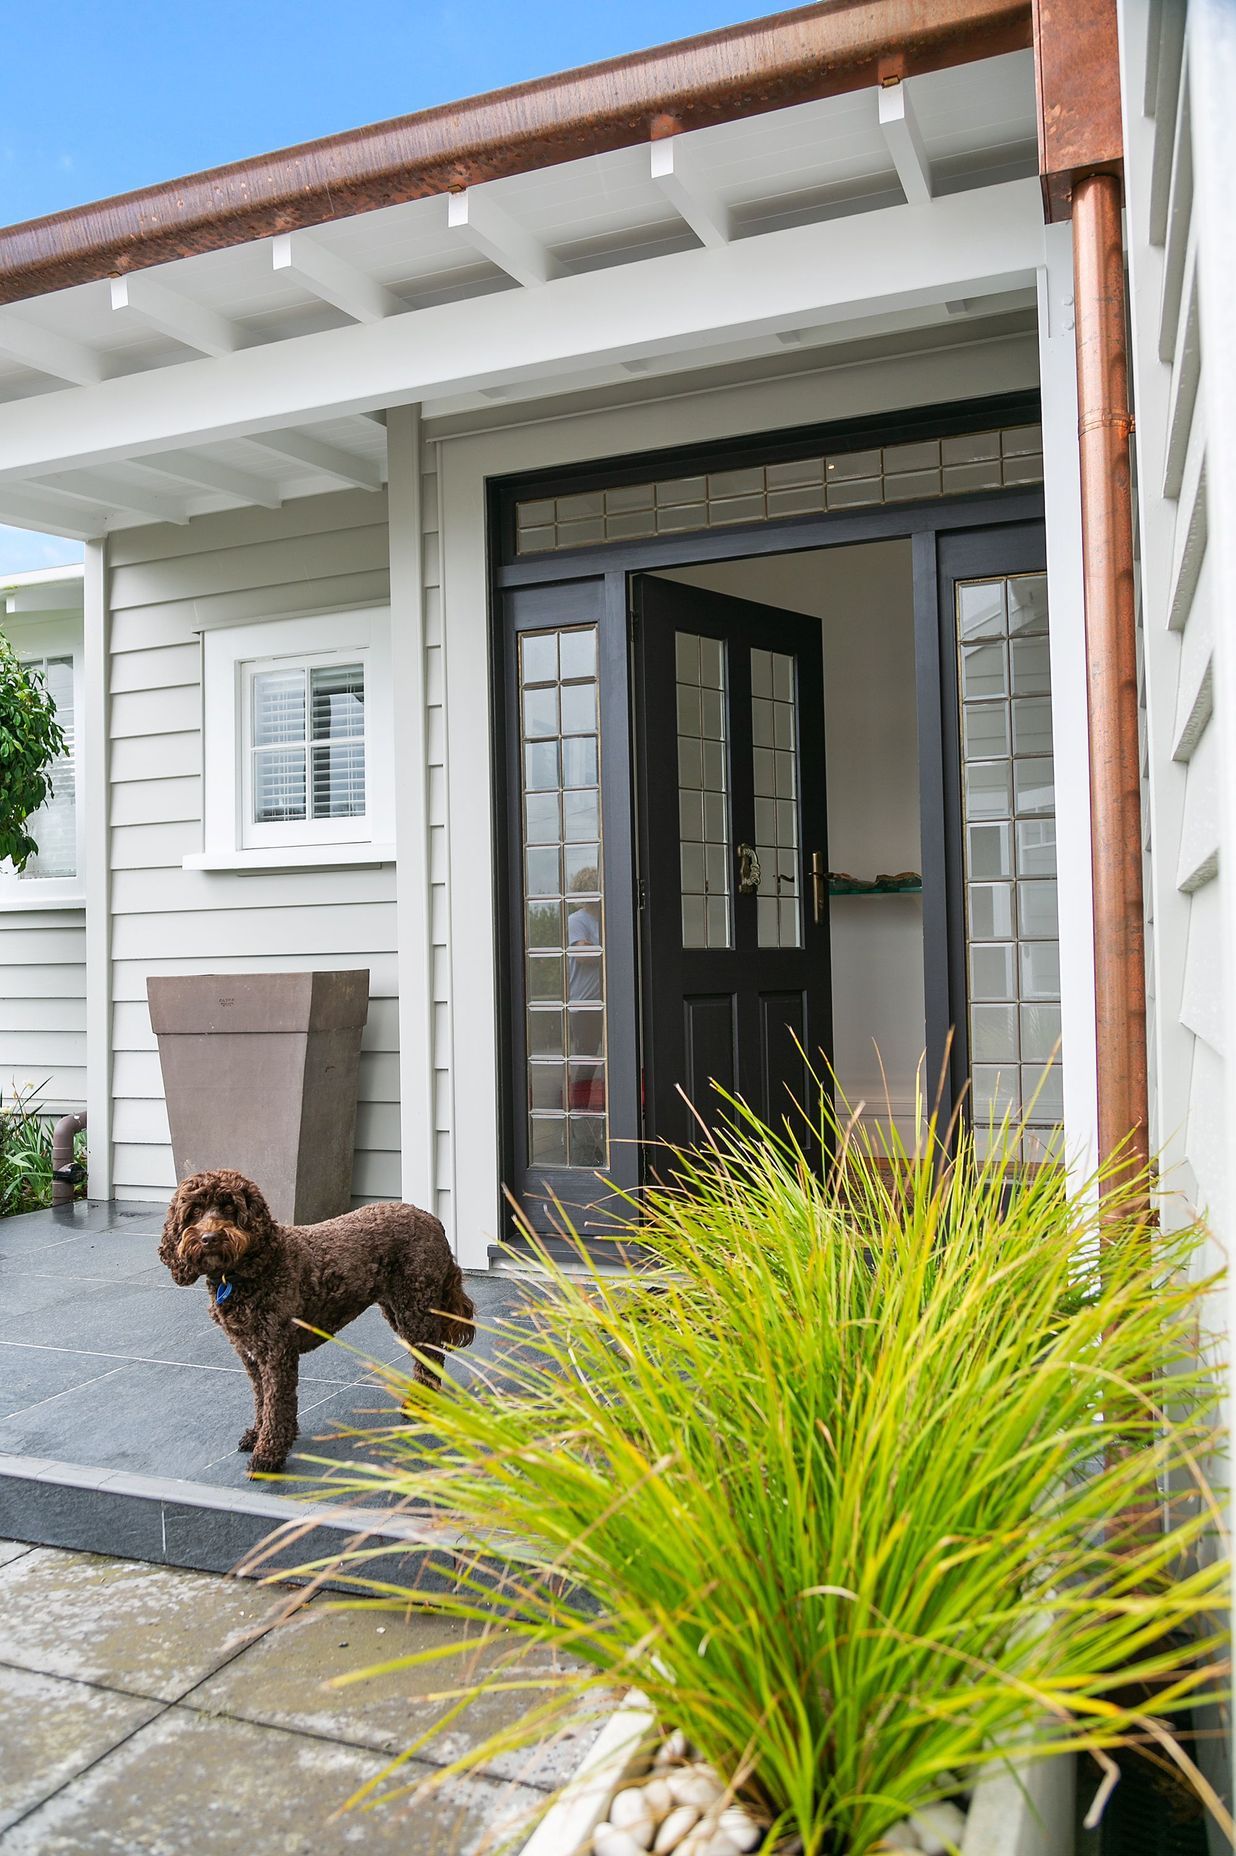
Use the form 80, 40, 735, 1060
488, 393, 1043, 1232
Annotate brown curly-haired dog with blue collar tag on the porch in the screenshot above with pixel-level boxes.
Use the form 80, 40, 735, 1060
160, 1173, 475, 1476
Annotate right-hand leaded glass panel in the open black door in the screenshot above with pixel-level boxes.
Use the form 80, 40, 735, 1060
752, 650, 802, 947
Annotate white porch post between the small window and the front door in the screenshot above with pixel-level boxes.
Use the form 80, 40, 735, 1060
386, 406, 436, 1212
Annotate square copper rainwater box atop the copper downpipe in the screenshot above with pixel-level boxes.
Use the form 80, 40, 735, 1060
1034, 0, 1125, 225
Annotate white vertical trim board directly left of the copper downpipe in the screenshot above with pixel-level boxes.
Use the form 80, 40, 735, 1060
1037, 223, 1099, 1179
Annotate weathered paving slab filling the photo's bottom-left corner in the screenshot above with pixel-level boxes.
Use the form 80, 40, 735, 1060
4, 1709, 544, 1856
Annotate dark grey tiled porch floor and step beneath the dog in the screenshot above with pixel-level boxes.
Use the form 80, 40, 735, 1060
0, 1205, 538, 1570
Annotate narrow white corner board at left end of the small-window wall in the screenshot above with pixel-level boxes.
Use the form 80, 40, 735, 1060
82, 540, 111, 1199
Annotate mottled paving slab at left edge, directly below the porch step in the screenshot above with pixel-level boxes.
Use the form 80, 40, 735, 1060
0, 1546, 286, 1702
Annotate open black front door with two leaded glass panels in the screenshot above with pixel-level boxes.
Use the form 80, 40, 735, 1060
635, 575, 831, 1167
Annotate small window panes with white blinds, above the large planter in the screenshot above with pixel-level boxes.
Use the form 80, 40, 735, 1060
251, 664, 366, 824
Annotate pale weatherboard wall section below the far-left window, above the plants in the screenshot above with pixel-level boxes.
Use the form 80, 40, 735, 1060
0, 909, 85, 1114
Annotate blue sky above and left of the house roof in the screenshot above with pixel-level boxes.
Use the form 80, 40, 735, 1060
0, 0, 749, 574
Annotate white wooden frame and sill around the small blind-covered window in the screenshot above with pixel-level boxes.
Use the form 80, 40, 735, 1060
184, 605, 395, 870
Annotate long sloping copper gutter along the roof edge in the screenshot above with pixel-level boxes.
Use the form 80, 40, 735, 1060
0, 0, 1030, 303
